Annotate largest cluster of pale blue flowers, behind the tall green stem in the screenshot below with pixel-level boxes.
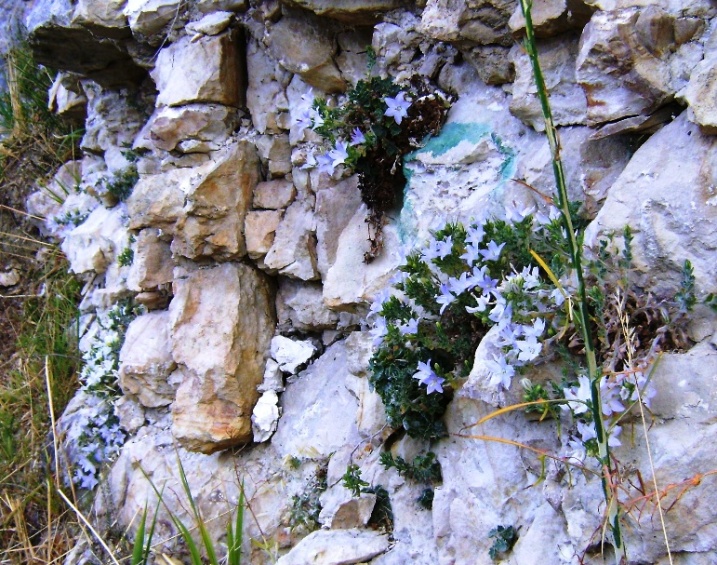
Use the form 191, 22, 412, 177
369, 206, 669, 459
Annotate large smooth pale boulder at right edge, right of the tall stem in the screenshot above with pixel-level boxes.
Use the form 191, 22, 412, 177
586, 112, 717, 294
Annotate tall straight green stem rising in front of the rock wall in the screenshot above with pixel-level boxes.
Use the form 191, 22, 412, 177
520, 0, 626, 563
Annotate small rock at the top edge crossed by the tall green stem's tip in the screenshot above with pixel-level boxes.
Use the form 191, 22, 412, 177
508, 0, 595, 37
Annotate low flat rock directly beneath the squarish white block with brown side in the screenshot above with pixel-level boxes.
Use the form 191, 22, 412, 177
134, 104, 239, 153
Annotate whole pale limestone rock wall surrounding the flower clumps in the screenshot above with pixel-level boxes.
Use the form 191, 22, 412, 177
29, 0, 717, 565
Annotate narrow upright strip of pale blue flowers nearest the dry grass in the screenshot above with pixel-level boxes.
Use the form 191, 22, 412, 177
72, 301, 140, 489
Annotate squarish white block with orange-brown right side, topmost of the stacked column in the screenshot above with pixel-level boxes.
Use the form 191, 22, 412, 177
151, 32, 246, 106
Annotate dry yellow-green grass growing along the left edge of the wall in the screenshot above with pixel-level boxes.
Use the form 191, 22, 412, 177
0, 40, 85, 564
